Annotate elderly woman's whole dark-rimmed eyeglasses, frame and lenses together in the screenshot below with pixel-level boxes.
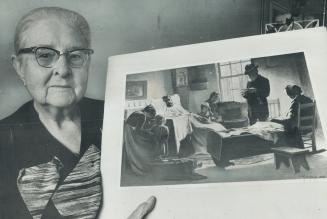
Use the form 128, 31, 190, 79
17, 47, 94, 68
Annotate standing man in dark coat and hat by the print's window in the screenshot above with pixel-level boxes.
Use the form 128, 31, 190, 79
242, 64, 270, 125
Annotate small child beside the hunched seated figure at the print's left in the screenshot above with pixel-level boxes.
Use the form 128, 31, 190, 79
151, 115, 169, 157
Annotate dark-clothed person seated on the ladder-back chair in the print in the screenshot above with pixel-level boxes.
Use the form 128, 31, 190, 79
271, 85, 314, 148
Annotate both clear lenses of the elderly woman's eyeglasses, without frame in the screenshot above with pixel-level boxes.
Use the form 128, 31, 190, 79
35, 47, 89, 68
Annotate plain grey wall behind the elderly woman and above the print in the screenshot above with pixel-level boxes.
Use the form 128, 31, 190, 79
0, 0, 261, 118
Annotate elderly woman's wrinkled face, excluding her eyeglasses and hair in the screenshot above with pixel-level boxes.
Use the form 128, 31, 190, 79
13, 18, 90, 108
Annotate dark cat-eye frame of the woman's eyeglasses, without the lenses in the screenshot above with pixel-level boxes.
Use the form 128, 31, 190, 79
17, 46, 94, 68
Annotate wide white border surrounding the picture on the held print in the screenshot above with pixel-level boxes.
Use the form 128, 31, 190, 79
101, 28, 327, 219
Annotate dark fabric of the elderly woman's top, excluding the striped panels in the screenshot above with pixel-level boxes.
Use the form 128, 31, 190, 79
0, 98, 104, 219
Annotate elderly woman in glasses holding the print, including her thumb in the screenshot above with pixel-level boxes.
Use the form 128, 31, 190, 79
0, 7, 154, 219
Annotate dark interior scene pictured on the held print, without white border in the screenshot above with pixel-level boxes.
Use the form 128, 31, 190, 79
121, 53, 327, 186
